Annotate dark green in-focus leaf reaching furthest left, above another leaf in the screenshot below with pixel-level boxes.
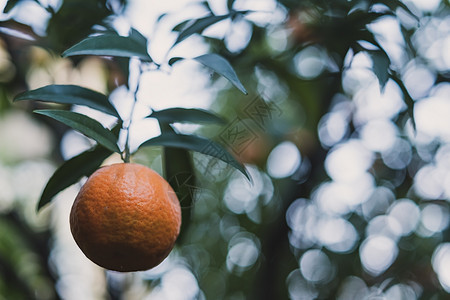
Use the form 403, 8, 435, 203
14, 84, 120, 118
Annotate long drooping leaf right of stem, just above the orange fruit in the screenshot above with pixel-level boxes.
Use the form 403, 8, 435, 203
140, 133, 250, 179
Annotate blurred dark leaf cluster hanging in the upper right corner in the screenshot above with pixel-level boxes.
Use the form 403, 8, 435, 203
296, 0, 419, 126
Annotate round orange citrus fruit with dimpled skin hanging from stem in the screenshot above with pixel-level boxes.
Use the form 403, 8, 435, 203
70, 163, 181, 272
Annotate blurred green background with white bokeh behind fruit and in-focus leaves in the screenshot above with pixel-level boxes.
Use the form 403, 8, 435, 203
0, 0, 450, 300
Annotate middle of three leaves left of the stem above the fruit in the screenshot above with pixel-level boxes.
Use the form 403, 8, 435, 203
34, 109, 120, 153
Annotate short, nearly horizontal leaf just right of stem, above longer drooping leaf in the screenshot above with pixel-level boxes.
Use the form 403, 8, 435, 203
148, 107, 225, 124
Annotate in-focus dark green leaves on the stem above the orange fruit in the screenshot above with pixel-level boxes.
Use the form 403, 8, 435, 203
14, 12, 253, 210
